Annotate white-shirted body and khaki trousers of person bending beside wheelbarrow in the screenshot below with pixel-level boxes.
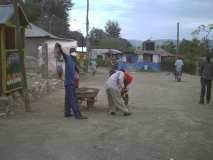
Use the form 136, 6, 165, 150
106, 70, 131, 116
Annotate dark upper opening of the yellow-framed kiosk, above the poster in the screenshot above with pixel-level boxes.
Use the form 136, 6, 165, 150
5, 27, 15, 49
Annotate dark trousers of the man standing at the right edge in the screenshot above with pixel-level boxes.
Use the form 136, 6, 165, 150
200, 78, 212, 102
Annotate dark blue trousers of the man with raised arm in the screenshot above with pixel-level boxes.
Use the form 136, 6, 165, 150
64, 85, 81, 117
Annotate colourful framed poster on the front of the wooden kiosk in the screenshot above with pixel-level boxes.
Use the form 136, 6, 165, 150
6, 52, 22, 93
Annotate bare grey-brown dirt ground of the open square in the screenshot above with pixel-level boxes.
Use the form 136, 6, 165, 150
0, 70, 213, 160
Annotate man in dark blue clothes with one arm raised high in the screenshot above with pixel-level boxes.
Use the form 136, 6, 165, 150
57, 43, 87, 119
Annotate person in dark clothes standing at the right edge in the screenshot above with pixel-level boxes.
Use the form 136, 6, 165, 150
199, 56, 213, 104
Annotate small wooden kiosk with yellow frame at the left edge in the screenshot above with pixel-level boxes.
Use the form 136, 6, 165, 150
0, 3, 29, 95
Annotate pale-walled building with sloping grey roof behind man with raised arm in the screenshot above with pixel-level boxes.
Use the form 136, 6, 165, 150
25, 24, 77, 74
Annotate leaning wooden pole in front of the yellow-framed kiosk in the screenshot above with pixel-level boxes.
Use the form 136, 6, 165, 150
12, 0, 31, 112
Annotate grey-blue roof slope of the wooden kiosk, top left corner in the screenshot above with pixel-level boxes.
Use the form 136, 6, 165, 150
0, 4, 14, 24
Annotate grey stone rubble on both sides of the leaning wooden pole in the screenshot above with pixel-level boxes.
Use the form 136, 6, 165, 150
0, 73, 63, 117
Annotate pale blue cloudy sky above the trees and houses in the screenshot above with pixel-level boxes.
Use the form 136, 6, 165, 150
70, 0, 213, 40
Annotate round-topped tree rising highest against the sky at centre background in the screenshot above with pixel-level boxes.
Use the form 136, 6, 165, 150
105, 20, 121, 38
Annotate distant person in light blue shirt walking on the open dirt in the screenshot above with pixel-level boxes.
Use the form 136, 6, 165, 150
175, 56, 184, 82
